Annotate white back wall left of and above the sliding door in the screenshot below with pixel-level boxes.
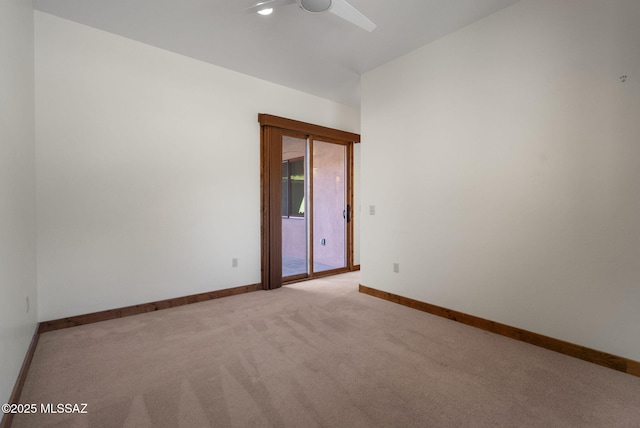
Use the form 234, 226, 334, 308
35, 12, 360, 320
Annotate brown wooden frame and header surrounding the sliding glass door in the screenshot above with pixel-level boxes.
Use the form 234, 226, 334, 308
258, 113, 360, 290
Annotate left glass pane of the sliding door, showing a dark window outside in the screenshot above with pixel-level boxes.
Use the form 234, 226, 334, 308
282, 135, 309, 277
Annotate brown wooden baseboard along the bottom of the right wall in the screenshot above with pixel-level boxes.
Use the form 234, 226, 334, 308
359, 284, 640, 377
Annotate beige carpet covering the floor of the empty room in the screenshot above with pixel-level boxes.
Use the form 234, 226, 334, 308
13, 272, 640, 428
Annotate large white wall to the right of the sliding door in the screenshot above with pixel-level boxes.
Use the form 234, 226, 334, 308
361, 0, 640, 360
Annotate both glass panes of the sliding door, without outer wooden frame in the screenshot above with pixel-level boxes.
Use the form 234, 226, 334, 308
282, 134, 350, 281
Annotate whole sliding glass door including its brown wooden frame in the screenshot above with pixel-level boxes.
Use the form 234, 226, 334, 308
259, 114, 360, 289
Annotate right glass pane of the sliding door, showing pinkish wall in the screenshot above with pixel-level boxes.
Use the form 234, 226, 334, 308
313, 140, 347, 272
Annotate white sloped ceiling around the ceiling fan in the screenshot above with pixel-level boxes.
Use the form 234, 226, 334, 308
34, 0, 518, 106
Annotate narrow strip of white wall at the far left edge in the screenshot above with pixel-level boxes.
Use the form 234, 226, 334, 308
0, 0, 37, 404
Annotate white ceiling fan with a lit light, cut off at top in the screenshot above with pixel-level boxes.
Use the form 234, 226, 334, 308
246, 0, 376, 32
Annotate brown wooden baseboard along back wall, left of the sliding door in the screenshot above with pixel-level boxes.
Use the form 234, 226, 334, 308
39, 284, 262, 333
